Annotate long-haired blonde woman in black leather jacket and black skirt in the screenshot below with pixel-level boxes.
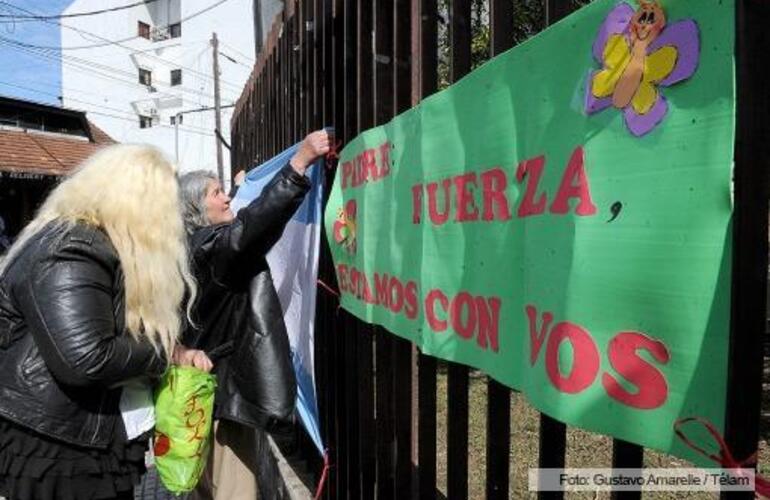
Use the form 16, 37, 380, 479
0, 145, 211, 500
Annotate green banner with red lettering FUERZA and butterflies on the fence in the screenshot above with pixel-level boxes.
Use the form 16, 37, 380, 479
325, 0, 735, 462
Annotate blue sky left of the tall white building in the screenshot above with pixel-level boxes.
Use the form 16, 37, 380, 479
0, 0, 72, 105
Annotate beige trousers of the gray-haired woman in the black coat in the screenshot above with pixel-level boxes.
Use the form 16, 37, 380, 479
190, 420, 259, 500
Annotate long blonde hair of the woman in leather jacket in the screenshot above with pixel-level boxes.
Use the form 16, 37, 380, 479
0, 144, 196, 359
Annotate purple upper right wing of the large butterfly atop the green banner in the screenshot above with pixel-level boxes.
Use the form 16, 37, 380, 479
647, 19, 700, 87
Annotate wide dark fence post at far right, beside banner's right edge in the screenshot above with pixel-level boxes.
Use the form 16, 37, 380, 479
722, 0, 770, 499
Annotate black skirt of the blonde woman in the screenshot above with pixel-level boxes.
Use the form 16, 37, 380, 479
0, 418, 148, 500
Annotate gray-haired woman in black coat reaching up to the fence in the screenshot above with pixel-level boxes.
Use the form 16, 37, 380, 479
180, 131, 329, 500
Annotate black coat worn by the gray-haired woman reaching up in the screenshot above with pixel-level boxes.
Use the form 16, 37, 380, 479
184, 165, 310, 430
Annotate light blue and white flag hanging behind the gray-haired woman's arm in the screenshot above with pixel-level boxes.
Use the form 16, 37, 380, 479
230, 144, 324, 454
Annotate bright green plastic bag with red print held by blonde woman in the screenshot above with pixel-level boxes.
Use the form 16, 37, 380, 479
153, 366, 217, 494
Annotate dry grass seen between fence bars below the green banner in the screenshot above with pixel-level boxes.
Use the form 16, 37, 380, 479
436, 370, 770, 500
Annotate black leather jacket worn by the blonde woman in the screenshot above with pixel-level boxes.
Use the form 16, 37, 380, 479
0, 224, 166, 448
